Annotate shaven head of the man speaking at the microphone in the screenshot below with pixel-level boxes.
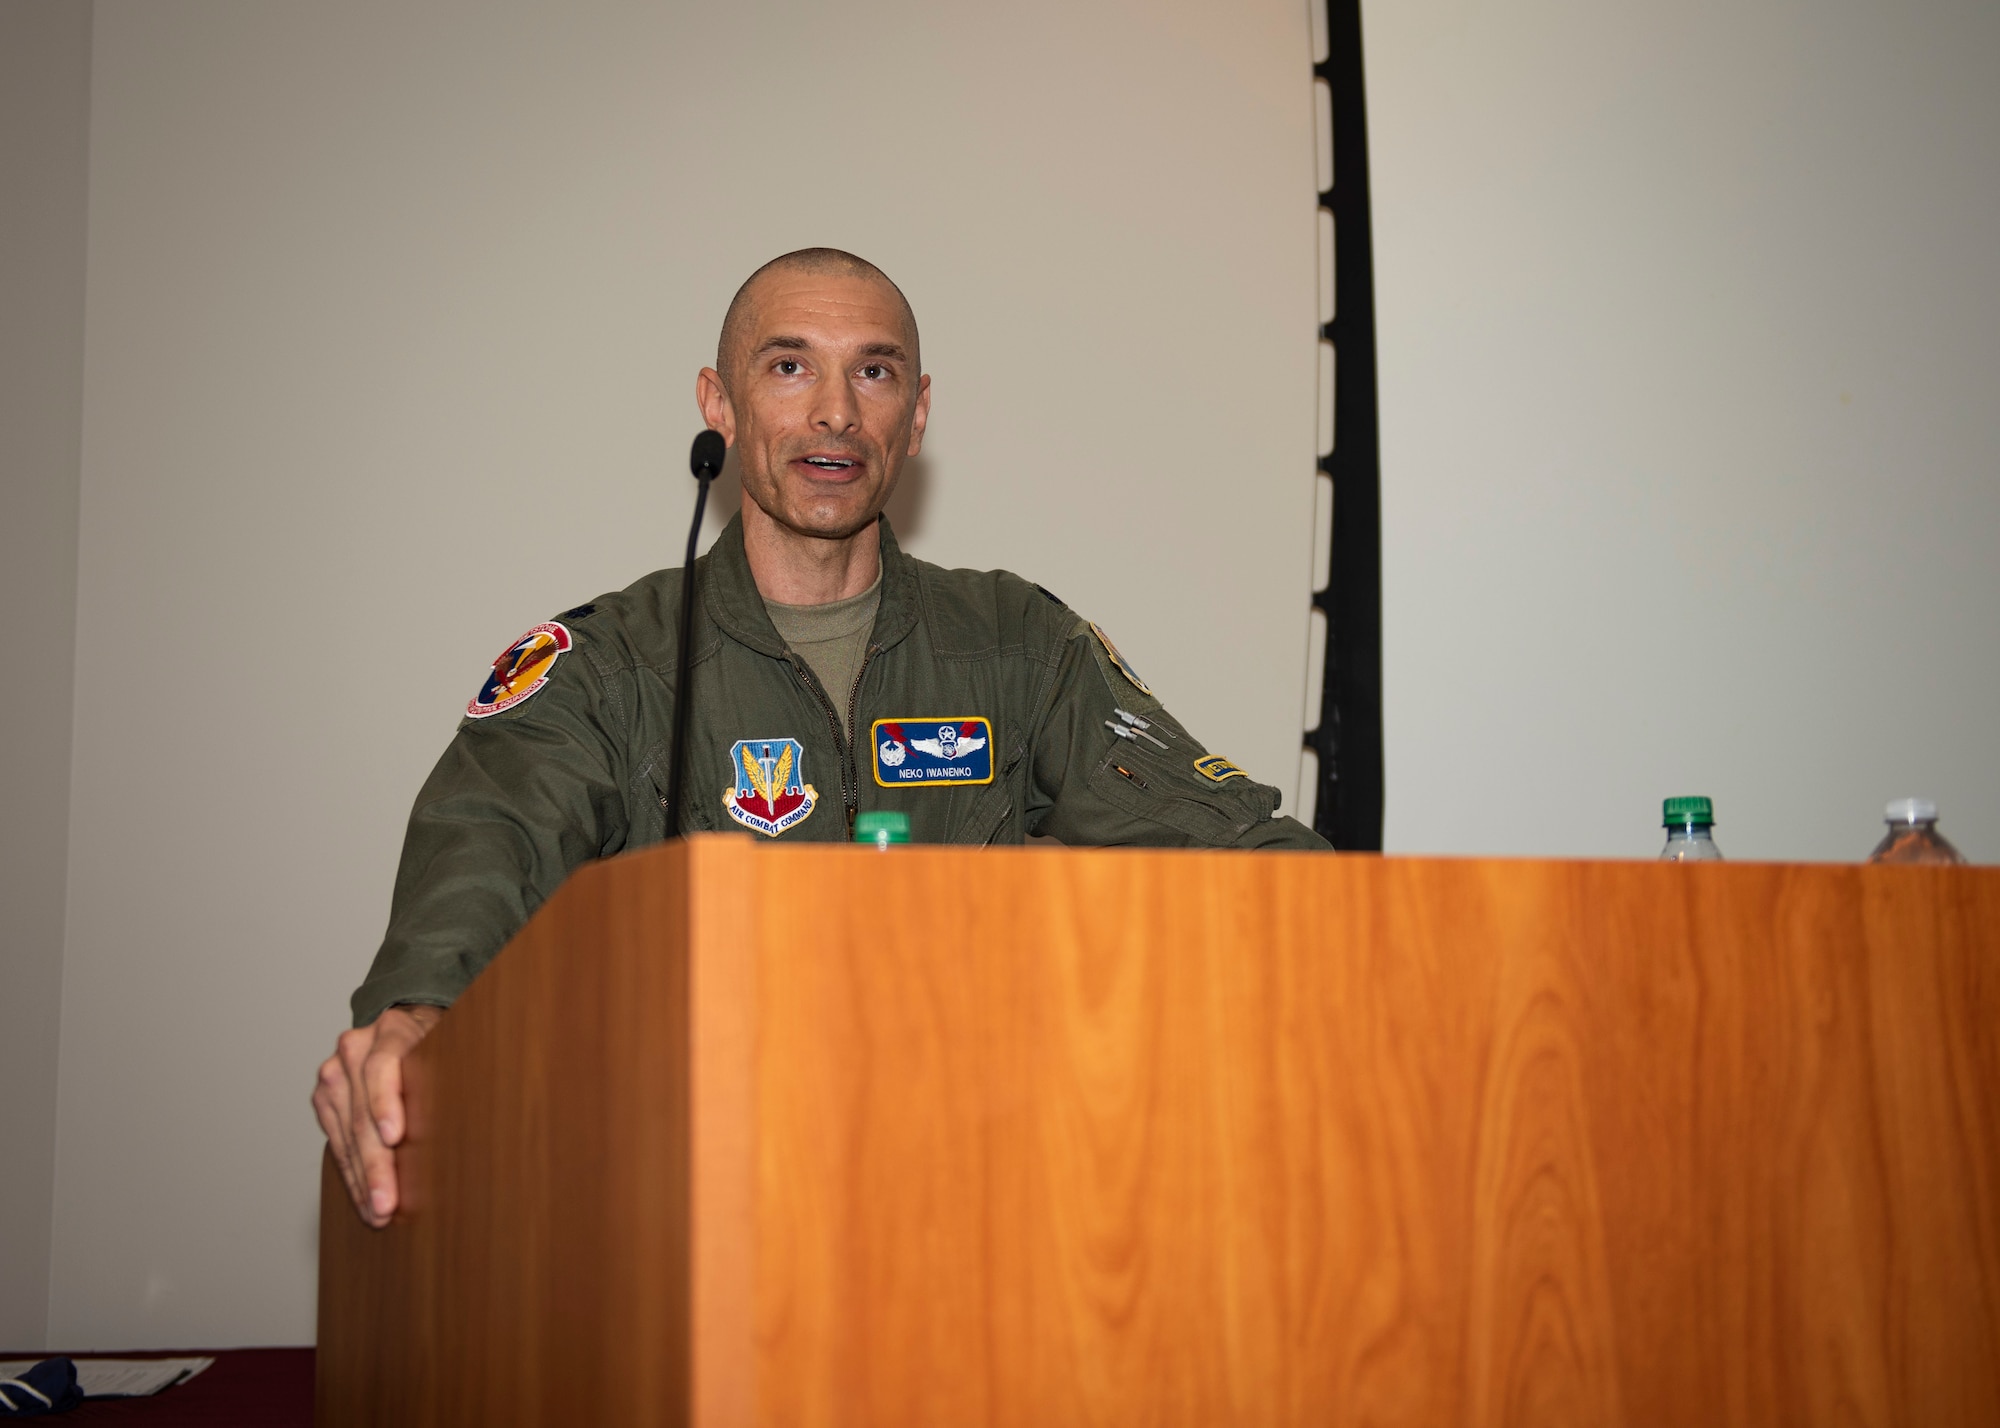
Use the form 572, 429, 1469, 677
694, 248, 930, 540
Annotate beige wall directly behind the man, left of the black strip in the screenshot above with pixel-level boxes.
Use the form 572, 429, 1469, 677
50, 0, 1314, 1346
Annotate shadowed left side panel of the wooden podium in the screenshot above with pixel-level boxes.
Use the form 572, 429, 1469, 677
316, 850, 690, 1428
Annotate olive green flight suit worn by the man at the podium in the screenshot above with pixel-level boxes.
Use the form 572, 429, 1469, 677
354, 516, 1328, 1026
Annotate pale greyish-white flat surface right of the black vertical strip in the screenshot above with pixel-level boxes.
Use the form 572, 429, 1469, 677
1366, 0, 2000, 862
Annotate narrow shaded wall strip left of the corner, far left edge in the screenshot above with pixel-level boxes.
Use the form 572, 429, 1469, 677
0, 0, 90, 1350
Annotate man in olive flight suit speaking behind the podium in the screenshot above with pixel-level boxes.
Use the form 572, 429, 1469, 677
312, 248, 1326, 1226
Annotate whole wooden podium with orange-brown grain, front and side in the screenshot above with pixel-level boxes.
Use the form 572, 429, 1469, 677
318, 836, 2000, 1428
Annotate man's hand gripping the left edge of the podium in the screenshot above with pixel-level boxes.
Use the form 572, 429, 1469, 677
312, 1006, 444, 1230
